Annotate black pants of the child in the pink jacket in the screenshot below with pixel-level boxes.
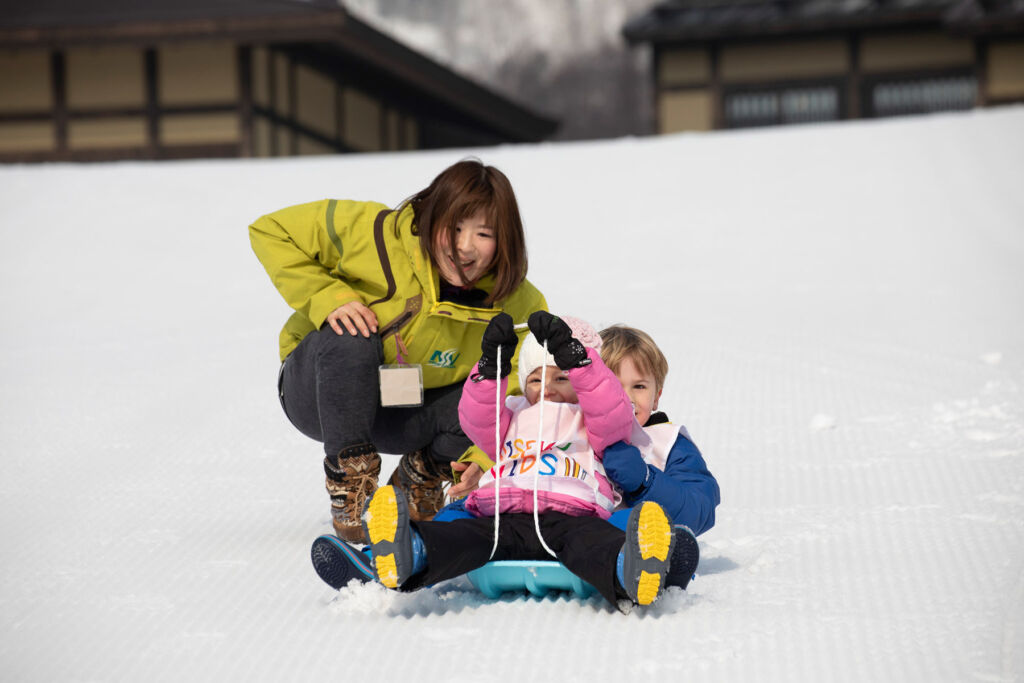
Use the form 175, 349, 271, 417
401, 512, 628, 605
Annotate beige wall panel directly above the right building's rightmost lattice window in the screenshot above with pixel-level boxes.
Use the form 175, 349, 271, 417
860, 33, 974, 72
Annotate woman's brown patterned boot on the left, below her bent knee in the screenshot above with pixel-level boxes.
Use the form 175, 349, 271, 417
324, 443, 381, 543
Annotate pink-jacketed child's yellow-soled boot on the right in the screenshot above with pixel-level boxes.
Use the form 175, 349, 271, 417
615, 501, 675, 605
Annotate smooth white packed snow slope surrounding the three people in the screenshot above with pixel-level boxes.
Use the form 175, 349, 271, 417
0, 109, 1024, 682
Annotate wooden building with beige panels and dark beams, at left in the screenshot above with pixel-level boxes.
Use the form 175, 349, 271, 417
0, 0, 556, 162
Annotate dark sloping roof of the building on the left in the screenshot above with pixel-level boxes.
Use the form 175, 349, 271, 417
0, 0, 558, 141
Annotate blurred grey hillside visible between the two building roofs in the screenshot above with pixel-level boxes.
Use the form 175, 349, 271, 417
342, 0, 655, 140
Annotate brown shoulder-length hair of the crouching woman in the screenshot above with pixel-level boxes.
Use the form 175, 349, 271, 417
398, 159, 527, 304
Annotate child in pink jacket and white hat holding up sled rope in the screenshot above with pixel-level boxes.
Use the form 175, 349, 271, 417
364, 311, 673, 608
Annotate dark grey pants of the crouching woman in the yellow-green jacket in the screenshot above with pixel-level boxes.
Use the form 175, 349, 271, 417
279, 325, 470, 462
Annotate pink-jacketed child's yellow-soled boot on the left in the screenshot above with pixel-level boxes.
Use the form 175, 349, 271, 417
362, 485, 427, 589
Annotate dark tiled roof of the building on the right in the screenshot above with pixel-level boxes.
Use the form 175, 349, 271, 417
623, 0, 1024, 43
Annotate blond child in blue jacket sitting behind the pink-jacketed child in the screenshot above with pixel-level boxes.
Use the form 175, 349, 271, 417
312, 325, 721, 589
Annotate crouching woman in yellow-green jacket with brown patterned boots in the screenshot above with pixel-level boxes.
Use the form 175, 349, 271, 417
249, 160, 547, 543
